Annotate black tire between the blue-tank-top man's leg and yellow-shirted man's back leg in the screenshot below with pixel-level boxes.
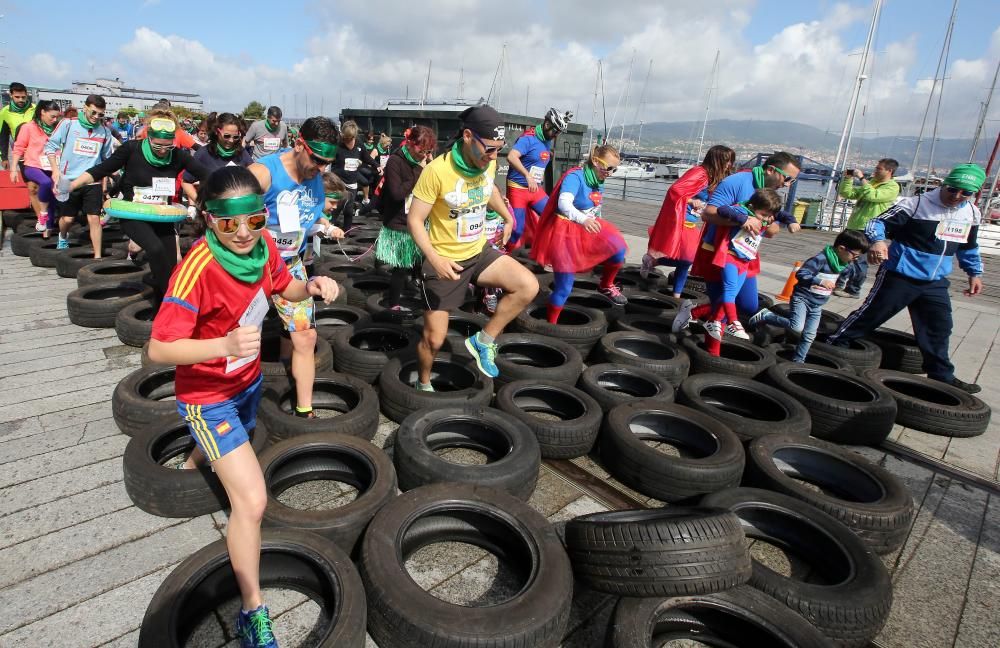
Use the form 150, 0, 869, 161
330, 324, 420, 383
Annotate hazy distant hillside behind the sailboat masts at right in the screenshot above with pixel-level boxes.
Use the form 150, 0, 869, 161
615, 119, 992, 169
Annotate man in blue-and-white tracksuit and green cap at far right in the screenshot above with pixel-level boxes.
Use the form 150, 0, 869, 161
828, 164, 986, 394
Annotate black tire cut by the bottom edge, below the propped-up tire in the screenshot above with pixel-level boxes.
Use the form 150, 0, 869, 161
609, 585, 833, 648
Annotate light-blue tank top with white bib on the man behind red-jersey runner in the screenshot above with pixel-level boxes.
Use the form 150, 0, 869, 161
257, 149, 325, 261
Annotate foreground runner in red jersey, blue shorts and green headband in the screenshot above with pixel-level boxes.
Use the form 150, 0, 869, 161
149, 166, 339, 648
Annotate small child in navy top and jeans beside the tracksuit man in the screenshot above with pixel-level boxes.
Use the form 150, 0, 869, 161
749, 230, 868, 362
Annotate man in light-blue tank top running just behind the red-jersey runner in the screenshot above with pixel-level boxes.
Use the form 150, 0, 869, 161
249, 117, 339, 418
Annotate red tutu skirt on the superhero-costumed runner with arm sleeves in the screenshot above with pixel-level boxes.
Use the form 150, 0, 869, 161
531, 217, 628, 273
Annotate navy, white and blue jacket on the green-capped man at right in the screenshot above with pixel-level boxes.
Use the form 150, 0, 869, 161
865, 189, 983, 281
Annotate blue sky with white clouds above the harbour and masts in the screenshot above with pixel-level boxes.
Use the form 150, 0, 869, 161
7, 0, 1000, 139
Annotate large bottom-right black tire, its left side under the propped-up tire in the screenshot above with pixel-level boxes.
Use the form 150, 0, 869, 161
701, 488, 892, 648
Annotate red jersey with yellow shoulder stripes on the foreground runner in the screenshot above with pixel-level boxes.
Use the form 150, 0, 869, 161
152, 231, 292, 405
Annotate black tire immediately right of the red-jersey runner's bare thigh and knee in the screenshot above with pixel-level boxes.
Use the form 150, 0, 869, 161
260, 432, 397, 554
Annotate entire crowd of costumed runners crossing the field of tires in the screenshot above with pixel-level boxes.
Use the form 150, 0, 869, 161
0, 83, 985, 646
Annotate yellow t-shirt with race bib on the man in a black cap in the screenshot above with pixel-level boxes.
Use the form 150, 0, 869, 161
413, 152, 497, 261
